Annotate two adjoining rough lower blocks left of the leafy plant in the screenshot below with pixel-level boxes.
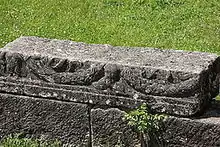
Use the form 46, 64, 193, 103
0, 94, 138, 146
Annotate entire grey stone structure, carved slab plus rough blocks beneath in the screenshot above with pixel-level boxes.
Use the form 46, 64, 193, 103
0, 37, 220, 147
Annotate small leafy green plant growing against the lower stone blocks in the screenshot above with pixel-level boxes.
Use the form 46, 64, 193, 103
124, 104, 166, 147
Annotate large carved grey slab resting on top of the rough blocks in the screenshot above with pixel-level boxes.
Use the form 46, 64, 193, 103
0, 37, 220, 116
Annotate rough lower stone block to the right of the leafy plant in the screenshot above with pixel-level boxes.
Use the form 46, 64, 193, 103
162, 118, 220, 147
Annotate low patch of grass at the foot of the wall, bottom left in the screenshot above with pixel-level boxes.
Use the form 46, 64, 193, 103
0, 134, 61, 147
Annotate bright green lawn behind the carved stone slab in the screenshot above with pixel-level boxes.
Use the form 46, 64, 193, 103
0, 0, 220, 54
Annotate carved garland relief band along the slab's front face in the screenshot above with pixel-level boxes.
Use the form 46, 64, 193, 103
0, 52, 199, 98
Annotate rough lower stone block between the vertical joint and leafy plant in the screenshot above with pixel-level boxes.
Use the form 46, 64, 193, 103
91, 108, 140, 147
